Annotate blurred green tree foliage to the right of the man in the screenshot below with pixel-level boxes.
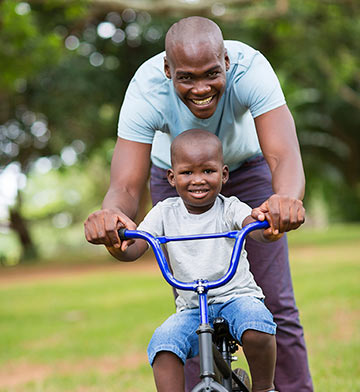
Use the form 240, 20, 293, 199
220, 0, 360, 220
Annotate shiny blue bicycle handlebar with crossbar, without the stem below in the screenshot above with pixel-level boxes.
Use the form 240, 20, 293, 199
118, 221, 269, 292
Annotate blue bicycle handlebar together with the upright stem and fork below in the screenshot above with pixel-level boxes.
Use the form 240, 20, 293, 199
119, 221, 269, 392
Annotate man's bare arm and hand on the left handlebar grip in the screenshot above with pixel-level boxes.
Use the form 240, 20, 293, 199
84, 138, 151, 250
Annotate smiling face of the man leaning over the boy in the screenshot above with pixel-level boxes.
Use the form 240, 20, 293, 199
164, 43, 230, 119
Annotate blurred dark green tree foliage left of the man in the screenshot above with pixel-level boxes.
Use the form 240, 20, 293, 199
0, 1, 167, 264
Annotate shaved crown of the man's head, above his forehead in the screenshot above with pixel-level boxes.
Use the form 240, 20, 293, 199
165, 16, 225, 61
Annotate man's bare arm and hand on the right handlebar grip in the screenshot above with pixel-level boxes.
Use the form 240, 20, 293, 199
252, 105, 305, 234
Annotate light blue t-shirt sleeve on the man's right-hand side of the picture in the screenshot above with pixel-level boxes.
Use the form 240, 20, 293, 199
235, 52, 286, 118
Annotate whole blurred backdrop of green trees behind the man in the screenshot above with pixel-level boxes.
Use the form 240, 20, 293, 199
0, 0, 360, 260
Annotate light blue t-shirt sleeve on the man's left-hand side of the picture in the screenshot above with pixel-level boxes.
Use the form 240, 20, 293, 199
118, 78, 159, 144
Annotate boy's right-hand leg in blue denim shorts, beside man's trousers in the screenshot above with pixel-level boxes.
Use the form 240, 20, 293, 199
219, 296, 276, 392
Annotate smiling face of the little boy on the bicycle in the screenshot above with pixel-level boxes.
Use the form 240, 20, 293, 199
168, 143, 229, 214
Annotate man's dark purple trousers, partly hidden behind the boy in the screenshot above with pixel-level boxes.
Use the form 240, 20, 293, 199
150, 157, 313, 392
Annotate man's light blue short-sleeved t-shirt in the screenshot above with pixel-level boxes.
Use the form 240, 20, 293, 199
118, 41, 285, 170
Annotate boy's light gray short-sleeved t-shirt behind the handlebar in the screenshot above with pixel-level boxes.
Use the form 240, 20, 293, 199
138, 195, 264, 311
